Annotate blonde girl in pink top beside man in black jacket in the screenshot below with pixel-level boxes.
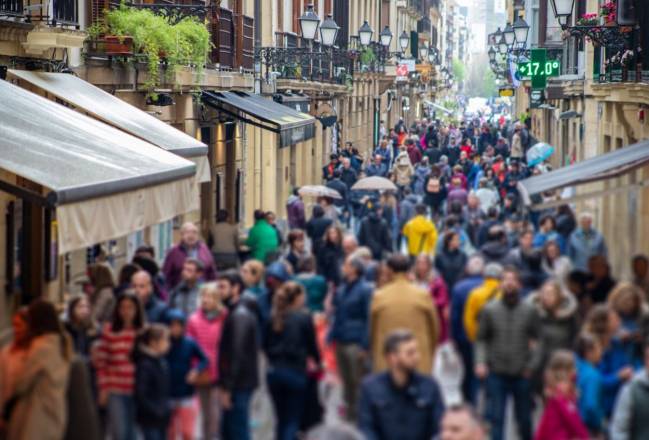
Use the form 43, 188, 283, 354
187, 282, 228, 439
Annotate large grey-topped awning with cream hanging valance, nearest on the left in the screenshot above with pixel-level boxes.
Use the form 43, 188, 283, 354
0, 77, 199, 254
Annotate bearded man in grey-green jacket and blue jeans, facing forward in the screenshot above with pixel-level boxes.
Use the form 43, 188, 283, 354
475, 267, 540, 440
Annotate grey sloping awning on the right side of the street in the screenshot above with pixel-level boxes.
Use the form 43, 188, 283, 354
518, 140, 649, 208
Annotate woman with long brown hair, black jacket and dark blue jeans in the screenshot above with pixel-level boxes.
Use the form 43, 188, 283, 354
264, 281, 320, 440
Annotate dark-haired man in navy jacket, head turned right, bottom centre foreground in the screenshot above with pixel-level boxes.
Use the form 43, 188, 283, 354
359, 330, 444, 440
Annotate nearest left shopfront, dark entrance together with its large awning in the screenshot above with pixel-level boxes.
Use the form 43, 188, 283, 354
0, 81, 199, 328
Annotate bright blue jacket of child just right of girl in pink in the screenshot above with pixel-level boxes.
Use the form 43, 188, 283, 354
576, 356, 604, 432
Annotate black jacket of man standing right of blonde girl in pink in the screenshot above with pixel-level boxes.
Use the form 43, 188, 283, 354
219, 299, 259, 391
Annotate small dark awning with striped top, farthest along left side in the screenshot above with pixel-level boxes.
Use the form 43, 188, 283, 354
202, 91, 315, 147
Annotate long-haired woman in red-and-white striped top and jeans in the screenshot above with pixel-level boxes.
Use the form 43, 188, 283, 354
94, 292, 144, 440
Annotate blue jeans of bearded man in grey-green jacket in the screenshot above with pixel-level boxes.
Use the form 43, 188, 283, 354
485, 373, 532, 440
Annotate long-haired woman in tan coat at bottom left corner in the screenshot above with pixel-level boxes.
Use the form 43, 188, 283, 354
7, 299, 72, 440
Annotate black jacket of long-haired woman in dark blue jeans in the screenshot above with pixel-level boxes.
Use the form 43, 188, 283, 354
264, 310, 320, 372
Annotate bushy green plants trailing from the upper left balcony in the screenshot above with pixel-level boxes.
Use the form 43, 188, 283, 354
106, 5, 211, 90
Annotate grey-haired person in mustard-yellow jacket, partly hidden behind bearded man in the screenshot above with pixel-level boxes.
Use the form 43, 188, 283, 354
464, 263, 503, 342
